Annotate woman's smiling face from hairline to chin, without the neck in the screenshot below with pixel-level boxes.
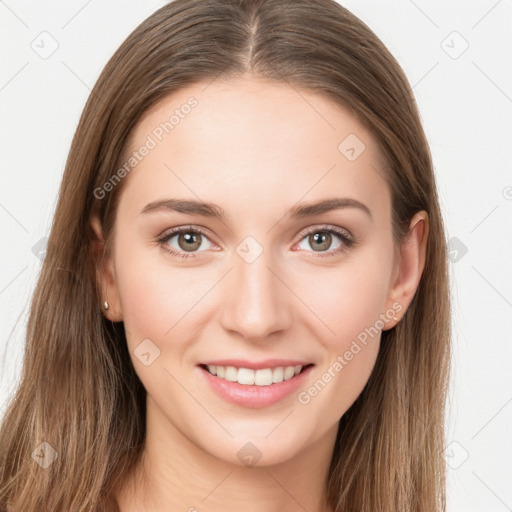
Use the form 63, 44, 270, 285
95, 76, 416, 465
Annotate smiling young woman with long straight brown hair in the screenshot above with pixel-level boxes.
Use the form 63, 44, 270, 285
0, 0, 450, 512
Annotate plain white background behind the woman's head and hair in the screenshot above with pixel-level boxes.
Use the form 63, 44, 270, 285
0, 0, 512, 512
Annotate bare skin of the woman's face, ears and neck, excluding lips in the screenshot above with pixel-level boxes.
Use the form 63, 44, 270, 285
92, 75, 428, 512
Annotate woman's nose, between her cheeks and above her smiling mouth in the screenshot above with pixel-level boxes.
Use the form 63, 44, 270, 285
221, 246, 293, 342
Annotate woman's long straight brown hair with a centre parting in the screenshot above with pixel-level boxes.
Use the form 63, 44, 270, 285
0, 0, 451, 512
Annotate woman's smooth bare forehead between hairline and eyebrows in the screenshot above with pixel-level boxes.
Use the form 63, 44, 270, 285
117, 77, 390, 224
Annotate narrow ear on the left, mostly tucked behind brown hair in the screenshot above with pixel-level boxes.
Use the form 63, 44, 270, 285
90, 215, 123, 322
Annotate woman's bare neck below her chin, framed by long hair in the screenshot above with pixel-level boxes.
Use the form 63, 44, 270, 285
116, 400, 338, 512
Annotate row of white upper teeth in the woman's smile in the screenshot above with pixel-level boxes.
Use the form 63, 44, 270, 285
208, 365, 302, 386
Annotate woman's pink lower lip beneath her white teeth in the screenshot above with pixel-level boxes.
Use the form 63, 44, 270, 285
198, 366, 313, 409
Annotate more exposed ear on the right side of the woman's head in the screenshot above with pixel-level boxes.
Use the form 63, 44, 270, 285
383, 210, 429, 330
